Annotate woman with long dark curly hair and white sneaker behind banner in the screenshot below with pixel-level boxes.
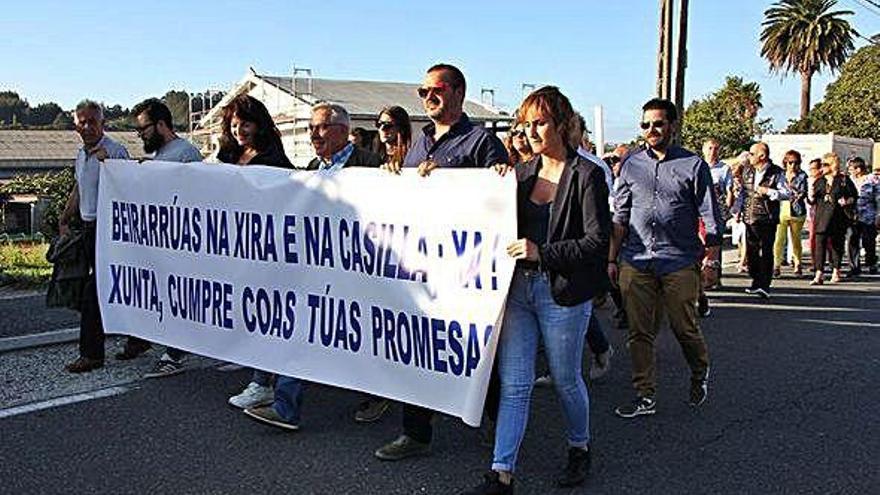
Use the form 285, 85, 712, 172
217, 95, 293, 409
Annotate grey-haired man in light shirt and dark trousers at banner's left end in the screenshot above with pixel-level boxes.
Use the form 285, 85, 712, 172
58, 100, 129, 373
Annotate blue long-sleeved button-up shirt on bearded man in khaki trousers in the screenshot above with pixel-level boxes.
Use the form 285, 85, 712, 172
614, 146, 722, 275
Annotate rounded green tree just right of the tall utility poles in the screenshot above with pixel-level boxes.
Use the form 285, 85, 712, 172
681, 76, 770, 156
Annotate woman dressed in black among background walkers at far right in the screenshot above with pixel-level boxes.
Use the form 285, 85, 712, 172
810, 153, 859, 285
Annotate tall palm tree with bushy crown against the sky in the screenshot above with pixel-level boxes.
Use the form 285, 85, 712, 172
761, 0, 858, 119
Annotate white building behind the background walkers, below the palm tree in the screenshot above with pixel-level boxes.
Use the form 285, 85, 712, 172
761, 133, 877, 169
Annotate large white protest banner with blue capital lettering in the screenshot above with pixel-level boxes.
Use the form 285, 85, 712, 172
97, 160, 516, 425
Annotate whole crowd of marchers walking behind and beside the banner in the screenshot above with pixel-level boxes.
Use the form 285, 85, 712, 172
51, 64, 880, 494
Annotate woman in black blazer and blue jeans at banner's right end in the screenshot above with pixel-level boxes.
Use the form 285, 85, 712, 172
466, 86, 611, 494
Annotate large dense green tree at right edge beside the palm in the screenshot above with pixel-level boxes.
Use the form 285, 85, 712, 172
788, 45, 880, 141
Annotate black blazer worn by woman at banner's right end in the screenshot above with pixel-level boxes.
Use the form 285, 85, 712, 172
516, 150, 611, 306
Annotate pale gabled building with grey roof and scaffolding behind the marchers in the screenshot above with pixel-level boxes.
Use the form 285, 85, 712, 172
192, 68, 512, 167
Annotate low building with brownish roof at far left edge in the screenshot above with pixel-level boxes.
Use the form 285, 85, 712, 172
0, 130, 144, 235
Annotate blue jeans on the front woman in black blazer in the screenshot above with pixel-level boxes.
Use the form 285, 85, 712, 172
492, 268, 592, 472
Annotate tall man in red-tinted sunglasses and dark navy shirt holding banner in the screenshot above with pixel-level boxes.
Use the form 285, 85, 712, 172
375, 64, 508, 461
